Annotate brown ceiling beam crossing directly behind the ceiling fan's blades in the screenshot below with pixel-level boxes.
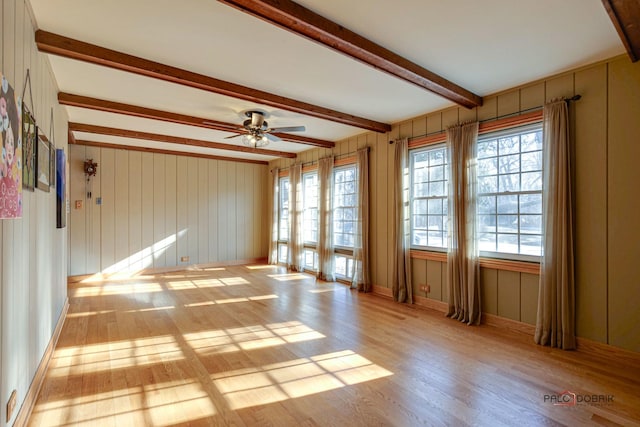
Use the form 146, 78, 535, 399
58, 92, 336, 148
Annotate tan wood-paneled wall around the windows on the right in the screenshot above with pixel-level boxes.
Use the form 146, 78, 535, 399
271, 57, 640, 351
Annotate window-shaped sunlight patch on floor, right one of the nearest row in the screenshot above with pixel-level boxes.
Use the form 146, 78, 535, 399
211, 350, 393, 410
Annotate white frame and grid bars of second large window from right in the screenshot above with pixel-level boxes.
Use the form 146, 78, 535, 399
409, 144, 449, 252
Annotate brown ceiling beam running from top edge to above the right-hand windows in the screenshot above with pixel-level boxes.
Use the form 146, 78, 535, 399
219, 0, 482, 108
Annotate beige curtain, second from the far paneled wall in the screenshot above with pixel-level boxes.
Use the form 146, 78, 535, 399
287, 164, 304, 271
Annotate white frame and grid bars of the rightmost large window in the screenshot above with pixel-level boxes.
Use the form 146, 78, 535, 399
476, 123, 544, 262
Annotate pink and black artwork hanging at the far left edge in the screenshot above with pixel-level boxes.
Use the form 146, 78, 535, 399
0, 73, 23, 219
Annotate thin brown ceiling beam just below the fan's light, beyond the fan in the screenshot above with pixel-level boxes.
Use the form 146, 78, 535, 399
69, 122, 297, 159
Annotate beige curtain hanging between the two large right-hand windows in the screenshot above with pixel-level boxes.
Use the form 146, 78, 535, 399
447, 122, 481, 325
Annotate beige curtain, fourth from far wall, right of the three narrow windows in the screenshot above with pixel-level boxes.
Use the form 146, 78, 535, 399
351, 147, 371, 292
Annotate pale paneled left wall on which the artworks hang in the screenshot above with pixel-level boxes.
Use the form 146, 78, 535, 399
0, 0, 68, 425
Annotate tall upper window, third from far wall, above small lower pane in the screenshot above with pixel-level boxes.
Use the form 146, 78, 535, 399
333, 165, 358, 249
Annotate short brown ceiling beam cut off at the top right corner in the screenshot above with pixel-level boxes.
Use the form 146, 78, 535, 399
602, 0, 640, 62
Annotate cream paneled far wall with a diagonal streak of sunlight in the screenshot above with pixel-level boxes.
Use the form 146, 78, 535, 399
69, 146, 268, 275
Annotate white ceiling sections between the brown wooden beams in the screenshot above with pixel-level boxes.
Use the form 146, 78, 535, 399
30, 0, 624, 164
